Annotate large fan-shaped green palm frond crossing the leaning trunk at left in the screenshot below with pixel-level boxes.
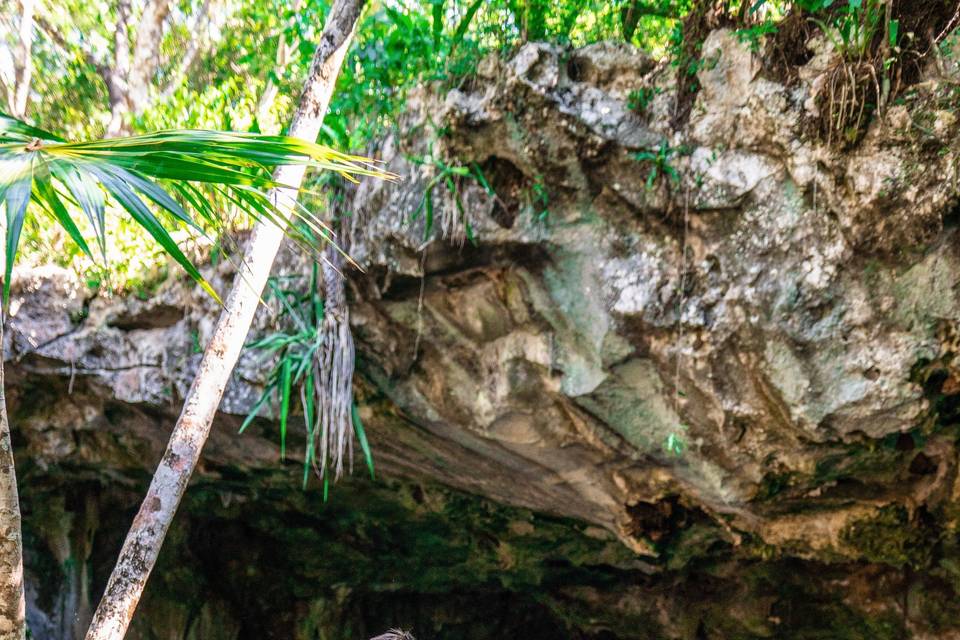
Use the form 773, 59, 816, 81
0, 113, 393, 305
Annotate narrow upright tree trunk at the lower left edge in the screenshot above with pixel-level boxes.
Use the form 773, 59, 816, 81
0, 318, 26, 640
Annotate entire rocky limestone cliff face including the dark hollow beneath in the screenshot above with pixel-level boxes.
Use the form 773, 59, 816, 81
9, 30, 960, 638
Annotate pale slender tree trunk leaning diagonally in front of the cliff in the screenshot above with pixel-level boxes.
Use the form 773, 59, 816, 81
87, 0, 365, 640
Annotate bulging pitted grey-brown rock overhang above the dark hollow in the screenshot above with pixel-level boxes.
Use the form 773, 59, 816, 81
342, 31, 960, 558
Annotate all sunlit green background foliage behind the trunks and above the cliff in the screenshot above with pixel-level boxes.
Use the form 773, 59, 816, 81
23, 0, 940, 286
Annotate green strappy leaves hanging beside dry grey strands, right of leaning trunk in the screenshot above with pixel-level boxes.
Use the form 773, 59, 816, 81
240, 265, 374, 490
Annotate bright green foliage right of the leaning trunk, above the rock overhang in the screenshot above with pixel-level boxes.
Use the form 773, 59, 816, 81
325, 0, 680, 149
